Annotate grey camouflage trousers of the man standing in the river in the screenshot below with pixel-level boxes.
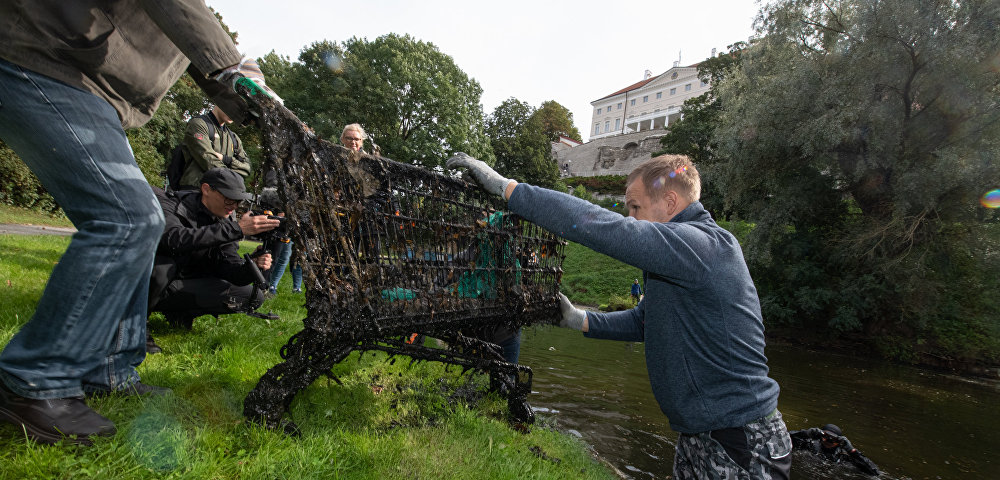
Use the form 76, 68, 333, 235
674, 409, 792, 480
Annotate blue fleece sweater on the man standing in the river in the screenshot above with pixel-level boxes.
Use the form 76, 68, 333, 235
508, 183, 778, 433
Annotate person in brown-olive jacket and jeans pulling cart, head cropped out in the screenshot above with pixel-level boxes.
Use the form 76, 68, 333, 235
0, 0, 282, 444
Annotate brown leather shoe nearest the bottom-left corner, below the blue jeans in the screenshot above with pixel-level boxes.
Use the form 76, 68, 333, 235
0, 381, 117, 445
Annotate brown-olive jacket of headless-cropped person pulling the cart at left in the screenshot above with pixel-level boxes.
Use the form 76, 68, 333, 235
0, 0, 246, 128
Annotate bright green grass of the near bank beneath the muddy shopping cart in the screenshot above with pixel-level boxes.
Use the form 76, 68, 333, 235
0, 235, 608, 479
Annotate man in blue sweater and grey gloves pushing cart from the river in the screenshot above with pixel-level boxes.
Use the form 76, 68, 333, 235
448, 154, 791, 479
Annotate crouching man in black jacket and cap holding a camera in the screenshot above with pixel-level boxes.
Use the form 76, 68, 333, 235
147, 168, 279, 348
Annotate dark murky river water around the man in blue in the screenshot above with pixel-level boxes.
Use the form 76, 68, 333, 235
520, 327, 1000, 479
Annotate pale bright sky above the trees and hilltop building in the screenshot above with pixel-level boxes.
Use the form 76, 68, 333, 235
206, 0, 760, 141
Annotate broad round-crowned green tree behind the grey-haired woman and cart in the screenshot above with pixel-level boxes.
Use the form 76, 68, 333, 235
262, 34, 493, 167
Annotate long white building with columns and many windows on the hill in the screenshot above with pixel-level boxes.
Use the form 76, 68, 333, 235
590, 62, 714, 141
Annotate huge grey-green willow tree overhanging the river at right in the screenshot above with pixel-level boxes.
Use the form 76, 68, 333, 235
713, 0, 1000, 359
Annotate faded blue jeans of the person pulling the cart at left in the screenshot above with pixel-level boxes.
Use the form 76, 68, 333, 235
0, 60, 163, 399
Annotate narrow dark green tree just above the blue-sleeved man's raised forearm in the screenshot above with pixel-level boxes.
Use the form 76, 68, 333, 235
486, 97, 559, 188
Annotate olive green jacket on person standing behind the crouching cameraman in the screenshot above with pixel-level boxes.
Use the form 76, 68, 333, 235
180, 112, 250, 188
